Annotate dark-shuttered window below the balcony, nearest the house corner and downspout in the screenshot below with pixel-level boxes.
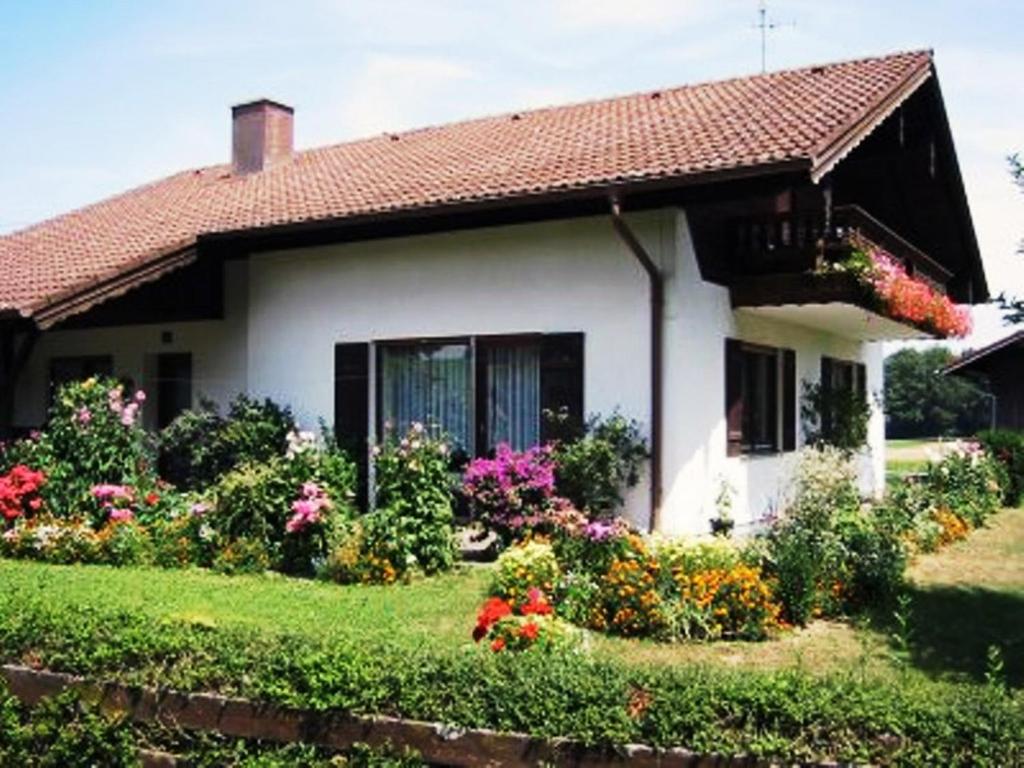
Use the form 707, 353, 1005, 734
725, 339, 797, 456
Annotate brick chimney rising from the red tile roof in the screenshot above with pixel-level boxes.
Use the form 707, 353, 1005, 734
231, 98, 295, 176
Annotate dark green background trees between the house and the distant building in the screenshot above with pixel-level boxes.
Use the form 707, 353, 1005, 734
885, 347, 991, 437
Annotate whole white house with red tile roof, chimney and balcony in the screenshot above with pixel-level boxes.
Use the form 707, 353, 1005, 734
0, 51, 988, 532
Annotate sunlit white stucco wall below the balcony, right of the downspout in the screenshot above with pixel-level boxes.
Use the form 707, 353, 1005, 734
662, 211, 885, 534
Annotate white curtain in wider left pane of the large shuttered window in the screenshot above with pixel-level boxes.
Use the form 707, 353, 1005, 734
378, 344, 473, 451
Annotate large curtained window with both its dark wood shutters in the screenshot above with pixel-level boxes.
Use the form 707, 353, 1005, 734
335, 333, 584, 468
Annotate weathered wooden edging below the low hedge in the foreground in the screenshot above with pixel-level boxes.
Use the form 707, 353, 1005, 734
0, 665, 864, 768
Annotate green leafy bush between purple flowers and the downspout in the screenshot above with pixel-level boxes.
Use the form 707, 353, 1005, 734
554, 414, 650, 517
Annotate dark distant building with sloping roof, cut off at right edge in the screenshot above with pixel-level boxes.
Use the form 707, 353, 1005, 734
943, 331, 1024, 430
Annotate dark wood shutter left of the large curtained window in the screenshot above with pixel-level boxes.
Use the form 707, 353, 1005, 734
334, 343, 370, 509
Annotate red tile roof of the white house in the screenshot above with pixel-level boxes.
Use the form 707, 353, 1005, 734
0, 51, 932, 325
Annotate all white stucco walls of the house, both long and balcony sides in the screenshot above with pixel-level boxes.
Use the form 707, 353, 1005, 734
17, 210, 885, 534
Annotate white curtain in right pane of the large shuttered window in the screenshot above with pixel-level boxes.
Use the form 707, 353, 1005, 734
481, 344, 541, 451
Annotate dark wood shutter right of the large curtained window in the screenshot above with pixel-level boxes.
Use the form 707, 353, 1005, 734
541, 333, 585, 442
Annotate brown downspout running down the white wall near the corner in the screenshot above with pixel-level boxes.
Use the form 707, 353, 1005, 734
609, 191, 665, 531
